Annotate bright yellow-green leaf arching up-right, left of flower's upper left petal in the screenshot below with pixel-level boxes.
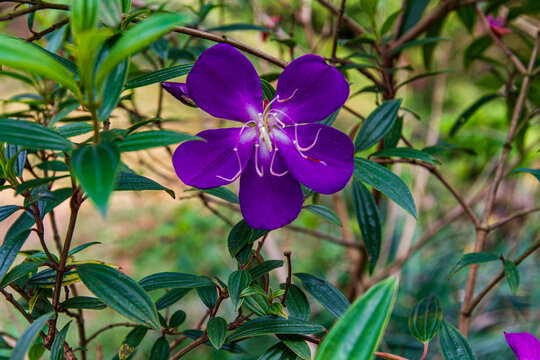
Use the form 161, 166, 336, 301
96, 14, 192, 86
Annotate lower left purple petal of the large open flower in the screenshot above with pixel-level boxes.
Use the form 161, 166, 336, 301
173, 128, 255, 189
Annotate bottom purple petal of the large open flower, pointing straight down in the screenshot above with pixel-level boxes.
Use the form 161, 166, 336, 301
239, 147, 303, 230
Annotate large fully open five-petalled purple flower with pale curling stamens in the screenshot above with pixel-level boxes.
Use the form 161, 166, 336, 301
169, 44, 354, 230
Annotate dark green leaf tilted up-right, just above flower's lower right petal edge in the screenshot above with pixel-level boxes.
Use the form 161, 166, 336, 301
354, 99, 401, 151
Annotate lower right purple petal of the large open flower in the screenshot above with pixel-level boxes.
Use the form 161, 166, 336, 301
275, 124, 354, 194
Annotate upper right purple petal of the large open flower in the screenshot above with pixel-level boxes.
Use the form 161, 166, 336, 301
272, 55, 349, 124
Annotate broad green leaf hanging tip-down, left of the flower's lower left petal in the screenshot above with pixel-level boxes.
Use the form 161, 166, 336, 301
71, 143, 120, 215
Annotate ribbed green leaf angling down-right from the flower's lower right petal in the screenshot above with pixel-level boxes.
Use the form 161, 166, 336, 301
353, 157, 416, 219
